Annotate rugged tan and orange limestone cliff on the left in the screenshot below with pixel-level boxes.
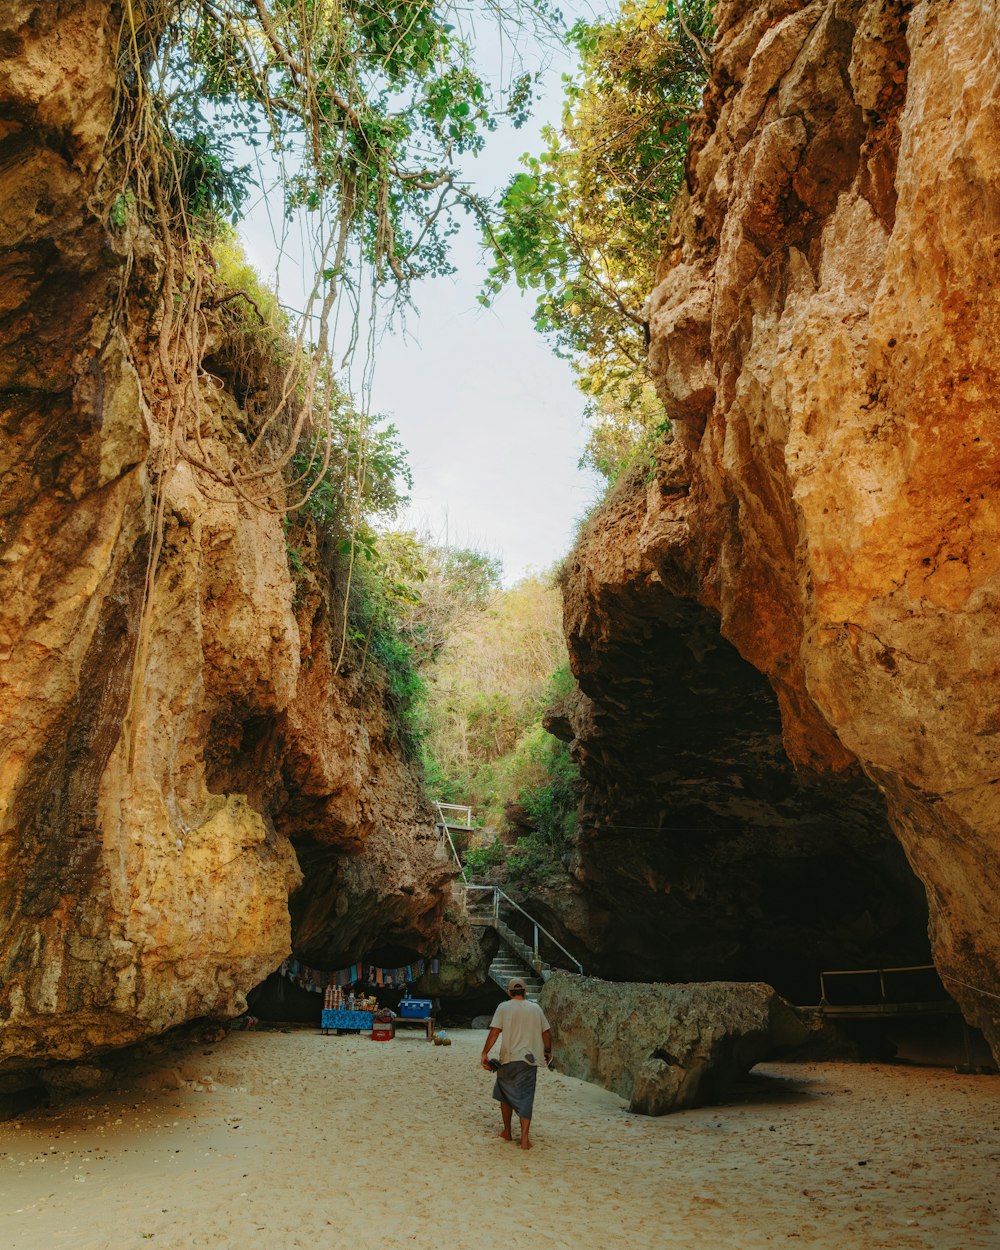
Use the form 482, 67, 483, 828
0, 0, 450, 1066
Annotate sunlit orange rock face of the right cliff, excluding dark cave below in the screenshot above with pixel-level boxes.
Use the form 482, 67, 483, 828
568, 0, 1000, 1053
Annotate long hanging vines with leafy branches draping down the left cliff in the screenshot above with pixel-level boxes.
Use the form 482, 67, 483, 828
108, 0, 558, 756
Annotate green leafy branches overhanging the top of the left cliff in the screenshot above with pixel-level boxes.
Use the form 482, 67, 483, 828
121, 0, 556, 286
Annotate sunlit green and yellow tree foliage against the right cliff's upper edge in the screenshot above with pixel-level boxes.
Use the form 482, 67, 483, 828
481, 0, 711, 474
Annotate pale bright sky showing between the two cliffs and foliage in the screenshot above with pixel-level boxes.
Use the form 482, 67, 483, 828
240, 5, 601, 585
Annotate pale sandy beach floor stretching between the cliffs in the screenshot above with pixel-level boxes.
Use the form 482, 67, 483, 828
0, 1030, 1000, 1250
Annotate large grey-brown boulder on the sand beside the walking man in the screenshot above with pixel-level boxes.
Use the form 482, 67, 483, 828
539, 973, 795, 1115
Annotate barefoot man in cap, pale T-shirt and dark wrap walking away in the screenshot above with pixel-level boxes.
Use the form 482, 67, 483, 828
480, 976, 553, 1150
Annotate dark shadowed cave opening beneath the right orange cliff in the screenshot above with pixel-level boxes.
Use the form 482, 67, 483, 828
549, 591, 930, 1004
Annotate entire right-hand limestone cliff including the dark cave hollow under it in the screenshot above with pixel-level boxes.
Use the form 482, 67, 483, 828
557, 0, 1000, 1051
